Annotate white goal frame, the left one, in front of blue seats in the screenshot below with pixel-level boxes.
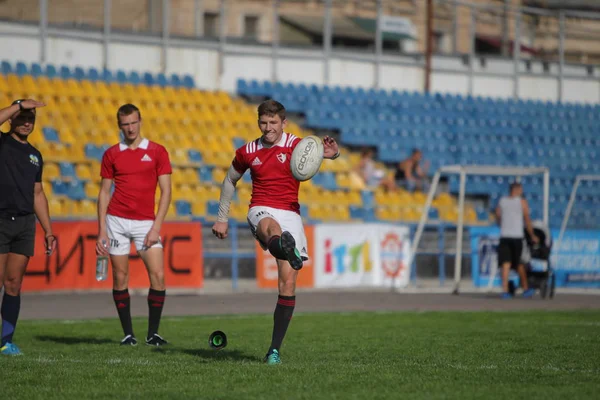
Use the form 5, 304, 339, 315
409, 165, 552, 294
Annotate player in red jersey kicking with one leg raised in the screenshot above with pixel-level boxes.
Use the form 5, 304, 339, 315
213, 100, 339, 364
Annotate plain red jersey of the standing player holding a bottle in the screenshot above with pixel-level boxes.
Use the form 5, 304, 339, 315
100, 139, 172, 220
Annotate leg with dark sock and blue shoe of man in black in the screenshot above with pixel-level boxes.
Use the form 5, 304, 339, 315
0, 253, 29, 355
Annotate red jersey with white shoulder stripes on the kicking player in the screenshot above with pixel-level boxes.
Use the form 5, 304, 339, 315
232, 132, 300, 214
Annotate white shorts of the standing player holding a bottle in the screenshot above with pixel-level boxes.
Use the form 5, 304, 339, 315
106, 215, 162, 256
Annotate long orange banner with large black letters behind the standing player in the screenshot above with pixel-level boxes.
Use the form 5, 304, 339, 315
23, 221, 204, 292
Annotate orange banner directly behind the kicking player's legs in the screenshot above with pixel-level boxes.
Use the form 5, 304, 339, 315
255, 225, 315, 289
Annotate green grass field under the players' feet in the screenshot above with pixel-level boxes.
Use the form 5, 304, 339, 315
0, 311, 600, 400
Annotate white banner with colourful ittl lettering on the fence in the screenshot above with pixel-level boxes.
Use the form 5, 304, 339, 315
314, 224, 410, 288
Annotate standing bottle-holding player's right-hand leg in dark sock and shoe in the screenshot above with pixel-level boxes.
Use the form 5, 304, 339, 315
139, 247, 167, 346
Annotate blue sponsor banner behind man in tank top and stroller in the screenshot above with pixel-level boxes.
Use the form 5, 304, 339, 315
470, 227, 600, 288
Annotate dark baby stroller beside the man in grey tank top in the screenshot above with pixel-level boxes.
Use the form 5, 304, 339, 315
508, 221, 556, 299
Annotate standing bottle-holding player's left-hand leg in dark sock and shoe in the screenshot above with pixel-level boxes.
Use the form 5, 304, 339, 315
110, 254, 137, 346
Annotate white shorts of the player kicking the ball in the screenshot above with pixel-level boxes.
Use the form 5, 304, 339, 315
248, 206, 308, 261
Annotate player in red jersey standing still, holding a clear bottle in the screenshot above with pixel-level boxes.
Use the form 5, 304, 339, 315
96, 104, 172, 346
